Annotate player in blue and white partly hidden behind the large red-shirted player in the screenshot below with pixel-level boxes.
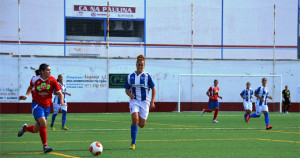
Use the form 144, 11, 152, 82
50, 74, 71, 130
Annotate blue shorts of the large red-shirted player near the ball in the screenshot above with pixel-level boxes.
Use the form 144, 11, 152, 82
31, 101, 50, 123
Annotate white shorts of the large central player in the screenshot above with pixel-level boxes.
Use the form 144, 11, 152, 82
129, 99, 150, 120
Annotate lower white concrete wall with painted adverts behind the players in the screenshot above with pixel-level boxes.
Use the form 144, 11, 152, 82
0, 55, 300, 102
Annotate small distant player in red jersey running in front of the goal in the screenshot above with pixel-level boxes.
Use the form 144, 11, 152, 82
201, 80, 222, 123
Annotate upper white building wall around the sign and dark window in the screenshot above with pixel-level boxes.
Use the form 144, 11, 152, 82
0, 0, 298, 59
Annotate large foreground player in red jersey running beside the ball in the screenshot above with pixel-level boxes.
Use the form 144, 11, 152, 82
18, 64, 64, 153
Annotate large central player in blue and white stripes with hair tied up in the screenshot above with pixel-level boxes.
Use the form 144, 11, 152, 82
124, 55, 156, 149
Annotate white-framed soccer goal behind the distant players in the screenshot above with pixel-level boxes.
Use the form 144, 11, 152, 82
175, 74, 282, 112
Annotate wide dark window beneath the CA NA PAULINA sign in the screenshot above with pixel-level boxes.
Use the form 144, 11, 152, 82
66, 18, 144, 42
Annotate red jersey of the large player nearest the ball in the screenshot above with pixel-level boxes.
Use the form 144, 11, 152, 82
30, 76, 61, 107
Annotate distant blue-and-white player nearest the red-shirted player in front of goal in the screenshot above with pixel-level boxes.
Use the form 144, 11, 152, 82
240, 82, 253, 122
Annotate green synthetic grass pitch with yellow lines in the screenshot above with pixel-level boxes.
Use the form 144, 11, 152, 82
0, 112, 300, 158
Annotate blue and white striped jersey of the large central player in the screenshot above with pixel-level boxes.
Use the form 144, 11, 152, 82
124, 72, 155, 101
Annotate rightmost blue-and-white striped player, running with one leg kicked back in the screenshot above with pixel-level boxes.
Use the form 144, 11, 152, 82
247, 78, 273, 130
